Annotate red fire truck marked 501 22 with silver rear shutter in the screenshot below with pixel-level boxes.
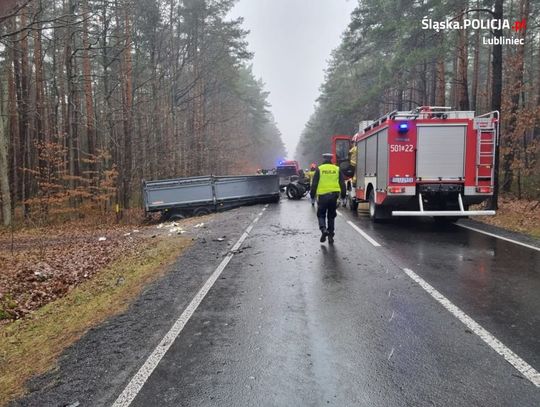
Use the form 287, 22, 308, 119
333, 106, 499, 221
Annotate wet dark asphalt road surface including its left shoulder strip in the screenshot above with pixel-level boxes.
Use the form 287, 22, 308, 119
10, 200, 540, 407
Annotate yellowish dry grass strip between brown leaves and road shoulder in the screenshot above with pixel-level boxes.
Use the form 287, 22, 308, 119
0, 237, 191, 405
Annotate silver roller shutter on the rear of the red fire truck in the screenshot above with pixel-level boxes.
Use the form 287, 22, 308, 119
416, 125, 467, 179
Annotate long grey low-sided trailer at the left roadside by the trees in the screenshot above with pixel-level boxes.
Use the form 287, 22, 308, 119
142, 175, 280, 219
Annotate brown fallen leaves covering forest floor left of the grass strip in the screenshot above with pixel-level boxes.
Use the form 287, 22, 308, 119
0, 225, 148, 323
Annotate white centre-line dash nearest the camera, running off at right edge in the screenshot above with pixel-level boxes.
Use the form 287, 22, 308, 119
403, 268, 540, 387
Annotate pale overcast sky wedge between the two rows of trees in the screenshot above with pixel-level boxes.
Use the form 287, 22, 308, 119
231, 0, 357, 158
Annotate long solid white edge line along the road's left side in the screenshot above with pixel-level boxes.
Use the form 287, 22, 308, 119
112, 216, 260, 407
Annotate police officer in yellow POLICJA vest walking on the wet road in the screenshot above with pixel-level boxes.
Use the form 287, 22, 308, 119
310, 154, 346, 243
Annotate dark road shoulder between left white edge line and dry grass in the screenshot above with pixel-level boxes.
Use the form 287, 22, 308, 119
7, 207, 260, 406
